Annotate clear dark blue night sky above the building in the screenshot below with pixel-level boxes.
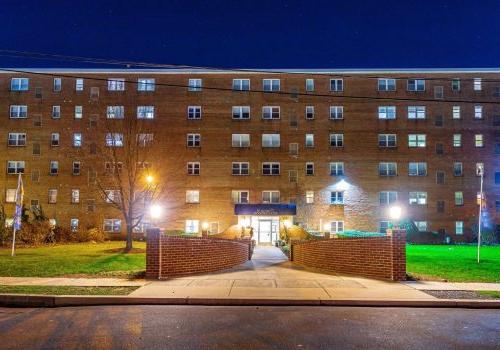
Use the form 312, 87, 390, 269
0, 0, 500, 68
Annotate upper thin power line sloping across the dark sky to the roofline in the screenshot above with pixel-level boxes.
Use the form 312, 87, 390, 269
0, 49, 500, 83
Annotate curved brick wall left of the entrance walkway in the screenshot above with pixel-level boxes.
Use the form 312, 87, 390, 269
146, 229, 253, 279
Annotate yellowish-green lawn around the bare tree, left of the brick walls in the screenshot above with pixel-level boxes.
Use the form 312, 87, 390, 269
0, 242, 146, 277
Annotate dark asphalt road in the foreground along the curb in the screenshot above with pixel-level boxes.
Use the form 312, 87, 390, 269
0, 306, 500, 350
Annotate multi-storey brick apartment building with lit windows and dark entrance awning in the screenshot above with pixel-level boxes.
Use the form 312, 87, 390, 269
0, 69, 500, 243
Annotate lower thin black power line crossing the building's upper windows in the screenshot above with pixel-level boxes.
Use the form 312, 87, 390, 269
0, 68, 499, 104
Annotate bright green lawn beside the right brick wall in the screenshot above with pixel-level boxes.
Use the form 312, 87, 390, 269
406, 245, 500, 282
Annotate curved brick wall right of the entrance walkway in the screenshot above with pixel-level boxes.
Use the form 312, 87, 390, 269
290, 230, 406, 281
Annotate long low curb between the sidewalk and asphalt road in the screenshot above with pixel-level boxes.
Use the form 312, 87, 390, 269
0, 294, 500, 309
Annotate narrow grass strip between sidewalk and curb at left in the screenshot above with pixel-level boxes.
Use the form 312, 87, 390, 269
0, 286, 139, 295
